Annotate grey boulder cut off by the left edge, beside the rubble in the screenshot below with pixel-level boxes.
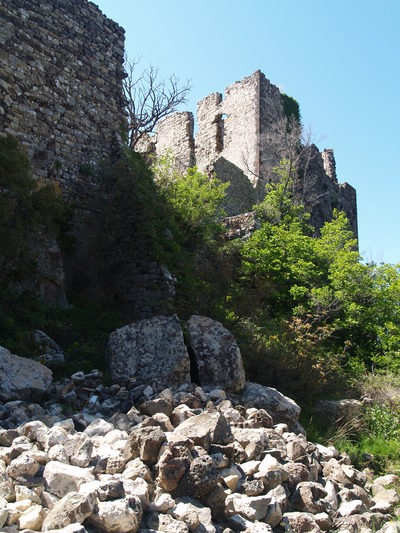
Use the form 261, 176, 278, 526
0, 346, 53, 402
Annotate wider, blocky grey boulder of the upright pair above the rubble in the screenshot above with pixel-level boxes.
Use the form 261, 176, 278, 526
107, 315, 190, 390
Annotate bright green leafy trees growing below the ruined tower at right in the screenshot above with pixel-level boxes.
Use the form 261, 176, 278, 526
222, 161, 400, 395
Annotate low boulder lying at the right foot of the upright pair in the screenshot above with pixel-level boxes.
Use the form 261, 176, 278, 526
239, 382, 304, 433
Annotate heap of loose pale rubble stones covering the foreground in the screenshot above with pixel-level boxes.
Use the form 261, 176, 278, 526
0, 316, 400, 533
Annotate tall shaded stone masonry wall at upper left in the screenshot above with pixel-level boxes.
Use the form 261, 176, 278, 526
0, 0, 124, 195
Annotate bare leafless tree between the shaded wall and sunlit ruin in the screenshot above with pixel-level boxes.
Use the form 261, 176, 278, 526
123, 59, 190, 149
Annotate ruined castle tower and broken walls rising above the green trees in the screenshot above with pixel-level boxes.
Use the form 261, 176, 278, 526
153, 70, 357, 235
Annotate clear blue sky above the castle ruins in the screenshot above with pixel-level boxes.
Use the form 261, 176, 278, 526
95, 0, 400, 263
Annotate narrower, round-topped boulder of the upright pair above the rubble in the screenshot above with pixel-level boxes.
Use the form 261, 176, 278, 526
187, 315, 245, 392
